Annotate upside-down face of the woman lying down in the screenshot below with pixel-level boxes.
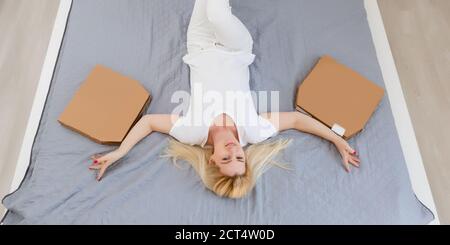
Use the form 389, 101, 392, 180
209, 141, 246, 177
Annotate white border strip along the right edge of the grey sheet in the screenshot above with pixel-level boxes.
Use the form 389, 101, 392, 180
365, 0, 439, 224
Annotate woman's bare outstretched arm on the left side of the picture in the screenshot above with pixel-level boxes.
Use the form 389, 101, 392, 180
89, 114, 178, 181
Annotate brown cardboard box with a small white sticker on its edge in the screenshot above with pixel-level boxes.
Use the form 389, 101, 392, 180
296, 56, 384, 139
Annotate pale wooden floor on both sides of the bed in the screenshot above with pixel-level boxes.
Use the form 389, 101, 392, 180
0, 0, 450, 224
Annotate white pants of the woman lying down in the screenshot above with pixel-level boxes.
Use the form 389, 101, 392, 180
187, 0, 253, 54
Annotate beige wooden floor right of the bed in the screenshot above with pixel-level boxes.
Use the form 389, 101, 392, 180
378, 0, 450, 224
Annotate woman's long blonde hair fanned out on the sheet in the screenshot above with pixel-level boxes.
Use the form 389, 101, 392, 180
165, 139, 291, 198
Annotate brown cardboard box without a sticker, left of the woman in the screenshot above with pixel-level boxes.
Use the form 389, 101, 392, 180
58, 65, 151, 145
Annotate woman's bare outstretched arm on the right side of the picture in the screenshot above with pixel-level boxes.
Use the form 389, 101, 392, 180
261, 112, 360, 172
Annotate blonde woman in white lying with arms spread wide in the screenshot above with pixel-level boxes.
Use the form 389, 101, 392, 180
89, 0, 360, 198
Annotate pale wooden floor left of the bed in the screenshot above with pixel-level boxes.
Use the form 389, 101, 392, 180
0, 0, 59, 217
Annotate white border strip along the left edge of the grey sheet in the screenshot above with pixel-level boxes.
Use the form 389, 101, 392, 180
10, 0, 72, 193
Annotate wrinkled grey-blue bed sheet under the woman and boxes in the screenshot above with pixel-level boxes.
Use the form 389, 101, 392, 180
3, 0, 433, 224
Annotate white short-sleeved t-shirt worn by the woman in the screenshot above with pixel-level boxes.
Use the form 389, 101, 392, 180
169, 45, 278, 147
